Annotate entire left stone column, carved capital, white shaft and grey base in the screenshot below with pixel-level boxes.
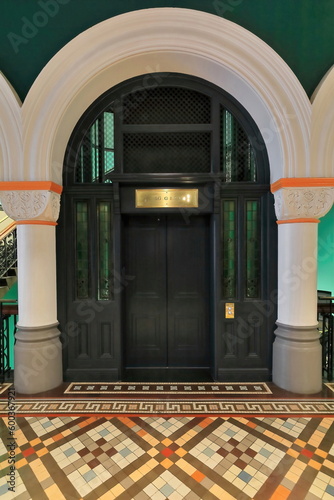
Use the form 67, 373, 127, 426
1, 187, 63, 394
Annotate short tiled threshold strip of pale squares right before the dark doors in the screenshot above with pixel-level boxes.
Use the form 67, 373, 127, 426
64, 382, 272, 395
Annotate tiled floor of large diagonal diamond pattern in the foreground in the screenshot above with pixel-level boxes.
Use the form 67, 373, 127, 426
0, 416, 334, 500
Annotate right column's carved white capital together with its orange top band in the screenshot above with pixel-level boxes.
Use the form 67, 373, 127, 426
271, 177, 334, 224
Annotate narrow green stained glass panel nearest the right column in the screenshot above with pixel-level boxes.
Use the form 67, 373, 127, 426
245, 200, 261, 299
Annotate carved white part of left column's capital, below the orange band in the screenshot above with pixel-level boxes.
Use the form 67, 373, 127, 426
1, 190, 60, 222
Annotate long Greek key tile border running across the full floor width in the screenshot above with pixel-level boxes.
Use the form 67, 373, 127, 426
0, 398, 334, 416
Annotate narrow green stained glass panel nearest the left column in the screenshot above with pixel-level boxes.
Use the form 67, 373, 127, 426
75, 201, 90, 299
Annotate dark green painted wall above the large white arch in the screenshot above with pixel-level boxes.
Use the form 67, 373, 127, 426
0, 0, 334, 100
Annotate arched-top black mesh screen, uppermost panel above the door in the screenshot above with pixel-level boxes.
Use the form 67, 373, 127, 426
123, 87, 211, 125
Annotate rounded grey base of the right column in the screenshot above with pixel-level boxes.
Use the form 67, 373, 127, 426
273, 323, 322, 394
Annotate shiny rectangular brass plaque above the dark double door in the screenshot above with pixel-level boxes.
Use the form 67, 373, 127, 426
136, 189, 198, 208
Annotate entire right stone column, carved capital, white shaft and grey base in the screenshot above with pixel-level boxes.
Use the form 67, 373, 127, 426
273, 187, 333, 394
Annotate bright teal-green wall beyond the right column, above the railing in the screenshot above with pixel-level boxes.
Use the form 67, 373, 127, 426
318, 206, 334, 295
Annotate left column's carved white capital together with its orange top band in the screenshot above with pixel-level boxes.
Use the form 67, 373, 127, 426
0, 181, 63, 226
